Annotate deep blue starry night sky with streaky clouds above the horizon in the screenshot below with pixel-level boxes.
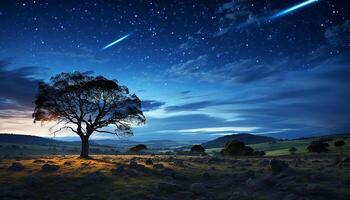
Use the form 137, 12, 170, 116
0, 0, 350, 140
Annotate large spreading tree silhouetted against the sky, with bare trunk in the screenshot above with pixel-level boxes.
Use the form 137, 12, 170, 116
33, 72, 146, 158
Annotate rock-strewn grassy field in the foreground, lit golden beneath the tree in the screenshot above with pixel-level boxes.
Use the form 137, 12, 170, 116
0, 155, 350, 200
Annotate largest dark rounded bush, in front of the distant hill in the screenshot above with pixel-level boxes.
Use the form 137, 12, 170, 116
223, 141, 254, 156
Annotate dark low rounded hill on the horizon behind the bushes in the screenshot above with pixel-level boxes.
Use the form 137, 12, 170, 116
202, 133, 277, 148
